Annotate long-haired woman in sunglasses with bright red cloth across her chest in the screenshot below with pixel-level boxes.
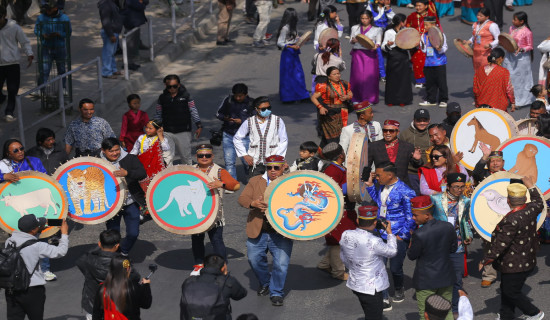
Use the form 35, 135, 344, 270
418, 145, 468, 196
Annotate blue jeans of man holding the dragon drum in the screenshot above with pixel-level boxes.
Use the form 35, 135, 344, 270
246, 232, 293, 297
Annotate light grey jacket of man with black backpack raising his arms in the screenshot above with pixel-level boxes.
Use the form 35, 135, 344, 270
5, 230, 69, 287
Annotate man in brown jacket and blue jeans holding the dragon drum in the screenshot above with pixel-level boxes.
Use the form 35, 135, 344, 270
239, 155, 293, 306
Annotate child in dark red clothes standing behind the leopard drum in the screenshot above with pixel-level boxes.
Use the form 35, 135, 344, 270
120, 94, 149, 150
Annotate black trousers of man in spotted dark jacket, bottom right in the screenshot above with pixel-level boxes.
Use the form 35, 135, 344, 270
500, 270, 540, 320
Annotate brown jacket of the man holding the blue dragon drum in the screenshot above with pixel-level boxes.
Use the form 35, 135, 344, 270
239, 176, 273, 239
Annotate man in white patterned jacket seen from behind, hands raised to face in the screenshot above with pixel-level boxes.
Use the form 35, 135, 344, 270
340, 206, 397, 320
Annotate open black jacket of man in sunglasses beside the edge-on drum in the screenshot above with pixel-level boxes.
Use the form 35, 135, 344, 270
367, 139, 423, 187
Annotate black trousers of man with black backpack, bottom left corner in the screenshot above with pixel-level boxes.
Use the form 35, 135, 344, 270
6, 286, 46, 320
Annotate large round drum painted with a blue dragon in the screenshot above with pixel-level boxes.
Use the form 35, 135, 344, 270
264, 170, 344, 240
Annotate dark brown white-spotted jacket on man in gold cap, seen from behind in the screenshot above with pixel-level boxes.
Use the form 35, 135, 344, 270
483, 188, 544, 273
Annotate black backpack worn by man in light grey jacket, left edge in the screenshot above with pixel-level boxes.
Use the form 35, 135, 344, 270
0, 239, 40, 292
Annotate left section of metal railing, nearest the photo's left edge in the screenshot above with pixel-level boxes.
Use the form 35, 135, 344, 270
15, 57, 105, 145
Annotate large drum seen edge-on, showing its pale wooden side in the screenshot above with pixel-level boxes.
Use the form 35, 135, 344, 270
346, 132, 369, 203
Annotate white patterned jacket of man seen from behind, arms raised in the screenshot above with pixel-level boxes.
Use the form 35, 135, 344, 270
340, 228, 397, 295
